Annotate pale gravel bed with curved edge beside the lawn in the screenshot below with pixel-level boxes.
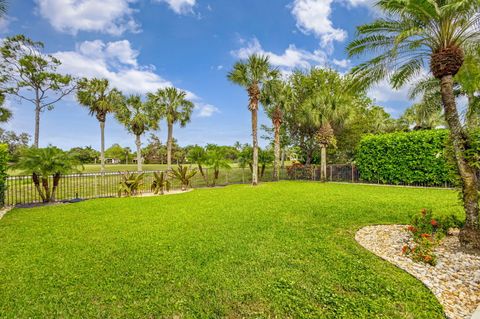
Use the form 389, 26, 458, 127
355, 225, 480, 319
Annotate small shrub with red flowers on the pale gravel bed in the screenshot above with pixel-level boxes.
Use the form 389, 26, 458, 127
402, 209, 462, 266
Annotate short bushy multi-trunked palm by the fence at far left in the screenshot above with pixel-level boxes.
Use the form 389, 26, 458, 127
13, 146, 80, 203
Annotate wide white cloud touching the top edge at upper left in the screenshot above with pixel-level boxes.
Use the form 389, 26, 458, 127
36, 0, 139, 35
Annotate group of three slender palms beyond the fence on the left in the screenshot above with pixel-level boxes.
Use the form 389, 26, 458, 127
76, 78, 194, 173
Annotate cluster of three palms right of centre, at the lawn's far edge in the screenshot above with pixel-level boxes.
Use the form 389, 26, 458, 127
228, 54, 364, 185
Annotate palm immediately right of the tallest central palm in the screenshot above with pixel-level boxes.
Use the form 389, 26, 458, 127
260, 79, 292, 180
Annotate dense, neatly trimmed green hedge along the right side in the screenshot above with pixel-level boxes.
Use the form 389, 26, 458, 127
356, 130, 454, 185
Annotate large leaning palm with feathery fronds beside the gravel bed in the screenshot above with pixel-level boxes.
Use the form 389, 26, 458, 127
348, 0, 480, 247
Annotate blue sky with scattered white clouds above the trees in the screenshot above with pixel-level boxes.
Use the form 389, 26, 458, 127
0, 0, 411, 148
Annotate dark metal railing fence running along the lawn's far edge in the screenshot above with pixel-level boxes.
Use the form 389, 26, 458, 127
5, 164, 480, 205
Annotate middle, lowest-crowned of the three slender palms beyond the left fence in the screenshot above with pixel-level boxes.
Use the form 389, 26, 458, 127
115, 95, 159, 172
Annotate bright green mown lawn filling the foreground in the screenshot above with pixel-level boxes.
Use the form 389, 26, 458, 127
0, 182, 461, 319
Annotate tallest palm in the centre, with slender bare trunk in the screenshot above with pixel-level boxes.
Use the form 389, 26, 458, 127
227, 54, 279, 186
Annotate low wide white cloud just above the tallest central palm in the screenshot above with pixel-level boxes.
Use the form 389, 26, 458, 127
231, 38, 327, 69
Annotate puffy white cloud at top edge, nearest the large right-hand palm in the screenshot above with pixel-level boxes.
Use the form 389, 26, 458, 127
292, 0, 347, 47
